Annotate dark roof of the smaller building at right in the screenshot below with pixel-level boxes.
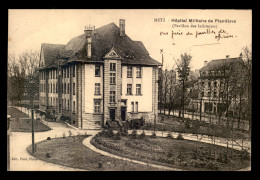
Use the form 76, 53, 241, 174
200, 57, 242, 72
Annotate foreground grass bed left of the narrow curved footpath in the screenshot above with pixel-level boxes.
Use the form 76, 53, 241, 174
27, 135, 165, 171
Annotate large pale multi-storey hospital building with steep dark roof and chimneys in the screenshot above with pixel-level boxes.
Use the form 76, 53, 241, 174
39, 19, 161, 129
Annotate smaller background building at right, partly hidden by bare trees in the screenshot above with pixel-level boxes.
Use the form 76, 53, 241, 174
192, 56, 246, 114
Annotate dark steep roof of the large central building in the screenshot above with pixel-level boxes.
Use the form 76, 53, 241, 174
42, 23, 161, 67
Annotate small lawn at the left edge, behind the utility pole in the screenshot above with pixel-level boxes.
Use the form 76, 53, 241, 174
7, 107, 51, 132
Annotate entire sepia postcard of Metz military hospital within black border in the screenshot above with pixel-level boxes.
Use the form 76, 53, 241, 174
7, 9, 252, 171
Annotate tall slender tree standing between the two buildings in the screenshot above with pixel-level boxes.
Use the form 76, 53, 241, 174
176, 53, 192, 118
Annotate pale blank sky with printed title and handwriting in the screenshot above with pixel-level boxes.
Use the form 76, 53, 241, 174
8, 9, 252, 70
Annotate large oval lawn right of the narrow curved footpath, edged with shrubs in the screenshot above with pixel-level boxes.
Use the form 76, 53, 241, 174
91, 133, 250, 171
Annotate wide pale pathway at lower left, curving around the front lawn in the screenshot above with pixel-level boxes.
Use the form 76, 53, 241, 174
10, 107, 95, 171
